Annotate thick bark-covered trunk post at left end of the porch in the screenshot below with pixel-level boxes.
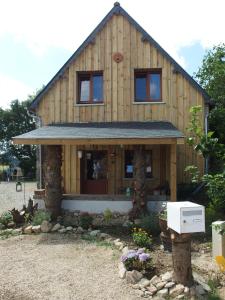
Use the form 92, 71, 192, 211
44, 145, 62, 219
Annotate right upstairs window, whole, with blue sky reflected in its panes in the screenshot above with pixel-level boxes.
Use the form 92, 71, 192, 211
134, 70, 162, 102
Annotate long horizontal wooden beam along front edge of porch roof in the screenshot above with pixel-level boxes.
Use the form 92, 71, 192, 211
13, 137, 183, 145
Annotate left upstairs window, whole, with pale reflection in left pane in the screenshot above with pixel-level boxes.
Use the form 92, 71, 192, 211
78, 72, 103, 104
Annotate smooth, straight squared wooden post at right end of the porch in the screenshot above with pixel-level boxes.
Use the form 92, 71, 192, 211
170, 144, 177, 201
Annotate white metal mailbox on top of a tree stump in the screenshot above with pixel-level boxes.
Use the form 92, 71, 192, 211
167, 201, 205, 233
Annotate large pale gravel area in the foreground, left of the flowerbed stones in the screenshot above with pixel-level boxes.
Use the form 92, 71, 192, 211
0, 234, 139, 300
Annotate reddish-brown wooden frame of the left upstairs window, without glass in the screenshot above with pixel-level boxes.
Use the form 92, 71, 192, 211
77, 71, 104, 105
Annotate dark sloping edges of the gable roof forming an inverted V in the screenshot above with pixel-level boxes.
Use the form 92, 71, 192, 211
30, 2, 210, 110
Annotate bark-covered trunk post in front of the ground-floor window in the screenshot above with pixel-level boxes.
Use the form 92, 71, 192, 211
133, 145, 146, 214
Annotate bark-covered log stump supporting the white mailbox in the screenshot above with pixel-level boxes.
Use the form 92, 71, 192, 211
171, 230, 193, 287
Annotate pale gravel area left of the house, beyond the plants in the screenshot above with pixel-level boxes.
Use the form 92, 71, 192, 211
0, 182, 36, 214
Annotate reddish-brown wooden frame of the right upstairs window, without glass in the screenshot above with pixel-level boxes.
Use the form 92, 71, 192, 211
134, 69, 162, 103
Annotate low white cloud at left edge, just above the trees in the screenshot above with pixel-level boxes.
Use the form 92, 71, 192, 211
0, 73, 33, 108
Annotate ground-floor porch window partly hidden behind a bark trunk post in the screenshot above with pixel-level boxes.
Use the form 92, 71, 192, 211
124, 150, 152, 178
